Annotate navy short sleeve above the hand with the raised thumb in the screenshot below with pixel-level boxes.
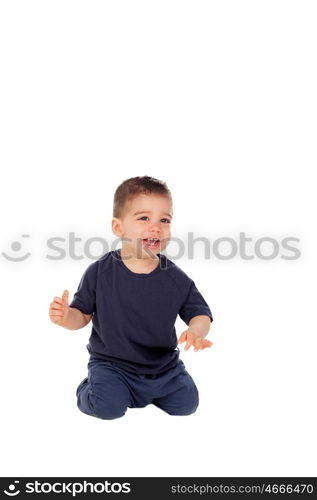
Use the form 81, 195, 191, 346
69, 262, 97, 314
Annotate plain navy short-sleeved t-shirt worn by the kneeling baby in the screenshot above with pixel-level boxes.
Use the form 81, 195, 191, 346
69, 249, 213, 374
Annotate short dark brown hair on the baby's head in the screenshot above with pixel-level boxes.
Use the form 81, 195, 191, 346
113, 175, 172, 218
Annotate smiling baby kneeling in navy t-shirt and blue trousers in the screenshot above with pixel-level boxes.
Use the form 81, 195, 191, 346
49, 176, 213, 420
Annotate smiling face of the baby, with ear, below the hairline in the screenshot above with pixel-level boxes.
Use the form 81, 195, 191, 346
112, 193, 173, 258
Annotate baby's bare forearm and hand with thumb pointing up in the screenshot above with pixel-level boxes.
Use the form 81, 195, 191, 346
49, 290, 92, 330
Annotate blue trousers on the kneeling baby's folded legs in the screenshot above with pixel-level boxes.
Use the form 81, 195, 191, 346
76, 355, 199, 420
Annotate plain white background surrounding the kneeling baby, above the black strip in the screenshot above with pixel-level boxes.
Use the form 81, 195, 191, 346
0, 0, 317, 477
